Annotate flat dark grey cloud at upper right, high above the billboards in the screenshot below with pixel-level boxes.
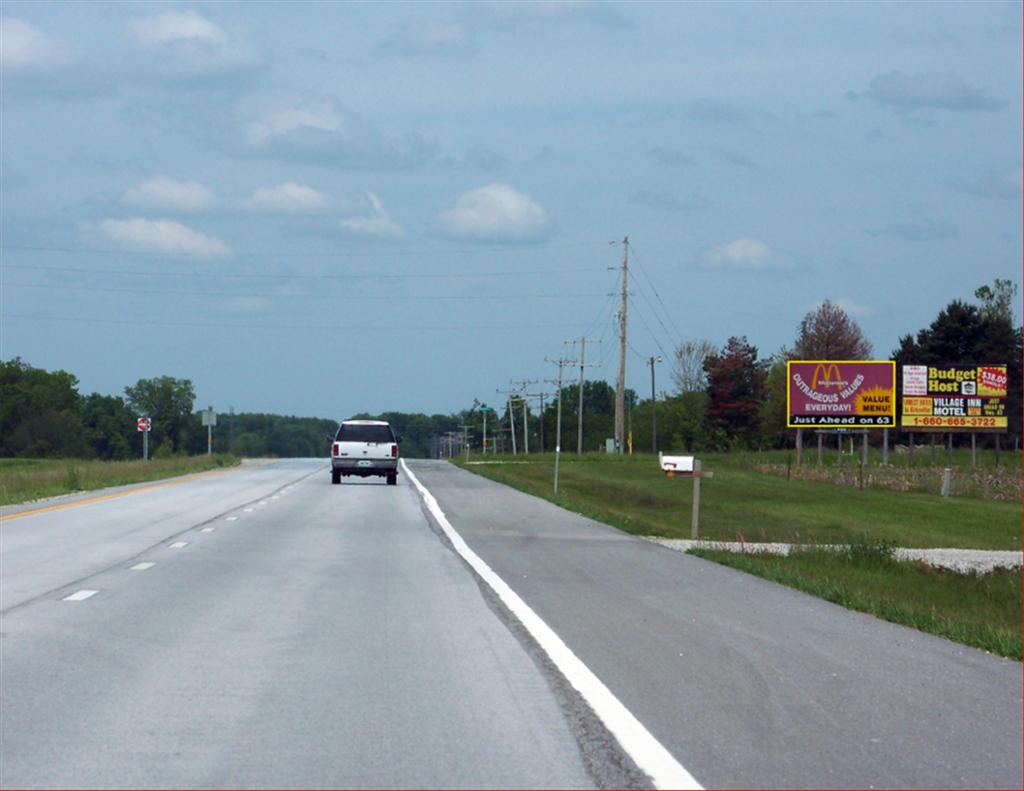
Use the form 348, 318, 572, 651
847, 72, 1007, 113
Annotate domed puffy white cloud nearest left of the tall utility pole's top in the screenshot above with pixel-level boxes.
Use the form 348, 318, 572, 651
438, 183, 551, 242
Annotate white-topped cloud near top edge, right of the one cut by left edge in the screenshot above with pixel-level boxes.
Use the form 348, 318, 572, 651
128, 10, 259, 86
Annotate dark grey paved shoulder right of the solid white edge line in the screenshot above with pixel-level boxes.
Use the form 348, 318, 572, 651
411, 462, 1024, 788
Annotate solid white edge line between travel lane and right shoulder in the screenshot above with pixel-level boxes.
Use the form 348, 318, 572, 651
400, 459, 703, 789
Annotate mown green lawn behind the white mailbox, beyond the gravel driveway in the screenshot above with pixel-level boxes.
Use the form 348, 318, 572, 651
456, 452, 1021, 550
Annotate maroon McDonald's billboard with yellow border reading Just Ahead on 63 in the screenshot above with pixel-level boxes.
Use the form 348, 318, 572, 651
785, 360, 896, 428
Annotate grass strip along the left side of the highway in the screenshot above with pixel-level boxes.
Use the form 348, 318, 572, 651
0, 454, 240, 505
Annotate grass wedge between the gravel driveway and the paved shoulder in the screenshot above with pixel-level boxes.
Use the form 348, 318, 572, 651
690, 543, 1022, 661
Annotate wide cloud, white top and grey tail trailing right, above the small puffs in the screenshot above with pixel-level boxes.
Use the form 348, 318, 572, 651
243, 95, 436, 170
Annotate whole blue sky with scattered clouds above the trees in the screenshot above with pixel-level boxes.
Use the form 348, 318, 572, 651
0, 0, 1022, 419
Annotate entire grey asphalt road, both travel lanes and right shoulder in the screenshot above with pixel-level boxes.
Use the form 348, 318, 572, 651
0, 460, 1022, 788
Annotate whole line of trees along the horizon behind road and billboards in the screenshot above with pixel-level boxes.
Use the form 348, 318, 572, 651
0, 280, 1022, 459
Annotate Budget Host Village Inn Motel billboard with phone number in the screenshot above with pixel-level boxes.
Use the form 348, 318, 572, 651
900, 365, 1009, 431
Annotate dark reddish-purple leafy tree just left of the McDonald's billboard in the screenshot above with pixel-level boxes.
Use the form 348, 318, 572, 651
705, 336, 765, 446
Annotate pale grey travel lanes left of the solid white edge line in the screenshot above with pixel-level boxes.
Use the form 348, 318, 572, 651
0, 460, 626, 788
